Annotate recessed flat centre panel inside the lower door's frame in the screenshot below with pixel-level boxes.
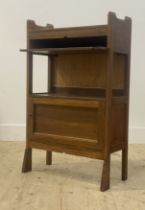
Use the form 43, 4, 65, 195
34, 105, 98, 141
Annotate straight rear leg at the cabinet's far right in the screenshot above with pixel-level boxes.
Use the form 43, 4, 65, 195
122, 147, 128, 181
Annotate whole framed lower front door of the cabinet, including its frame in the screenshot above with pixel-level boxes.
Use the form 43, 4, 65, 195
29, 98, 105, 151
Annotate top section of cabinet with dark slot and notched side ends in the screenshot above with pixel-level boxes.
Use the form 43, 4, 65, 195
24, 12, 131, 54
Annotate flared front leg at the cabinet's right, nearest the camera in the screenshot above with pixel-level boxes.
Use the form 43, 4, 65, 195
100, 155, 110, 192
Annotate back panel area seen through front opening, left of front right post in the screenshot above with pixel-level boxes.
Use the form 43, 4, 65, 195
52, 53, 107, 88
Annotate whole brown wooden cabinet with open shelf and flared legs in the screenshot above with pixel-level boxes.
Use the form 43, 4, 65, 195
22, 12, 131, 191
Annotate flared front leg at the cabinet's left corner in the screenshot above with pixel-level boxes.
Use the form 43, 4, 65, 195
22, 148, 32, 173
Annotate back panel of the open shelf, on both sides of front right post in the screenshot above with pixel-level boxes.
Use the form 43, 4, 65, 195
52, 53, 125, 89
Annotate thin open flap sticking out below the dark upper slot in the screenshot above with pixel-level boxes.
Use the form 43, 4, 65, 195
21, 47, 108, 55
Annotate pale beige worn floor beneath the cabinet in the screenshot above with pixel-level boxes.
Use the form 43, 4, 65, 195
0, 142, 145, 210
